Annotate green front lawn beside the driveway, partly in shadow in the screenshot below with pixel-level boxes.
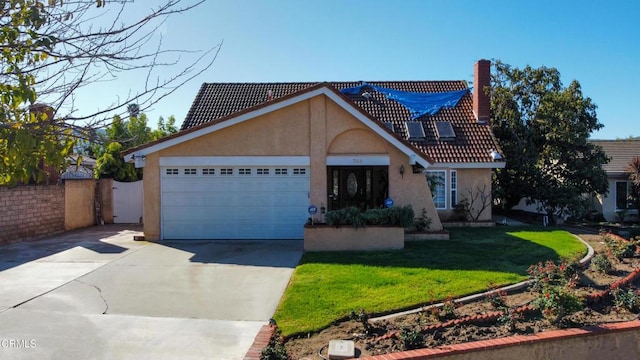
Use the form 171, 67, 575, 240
274, 226, 586, 336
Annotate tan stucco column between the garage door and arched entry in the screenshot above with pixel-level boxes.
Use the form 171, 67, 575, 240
308, 95, 327, 218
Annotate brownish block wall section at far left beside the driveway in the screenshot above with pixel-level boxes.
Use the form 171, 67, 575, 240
0, 185, 64, 244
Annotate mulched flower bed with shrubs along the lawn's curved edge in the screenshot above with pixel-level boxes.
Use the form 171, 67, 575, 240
286, 232, 640, 359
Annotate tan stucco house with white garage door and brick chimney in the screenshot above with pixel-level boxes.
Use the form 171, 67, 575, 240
123, 60, 504, 241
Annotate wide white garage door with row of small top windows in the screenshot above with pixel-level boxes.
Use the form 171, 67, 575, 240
161, 166, 310, 239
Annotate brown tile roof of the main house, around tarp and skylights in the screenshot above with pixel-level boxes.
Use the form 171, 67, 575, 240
181, 81, 499, 163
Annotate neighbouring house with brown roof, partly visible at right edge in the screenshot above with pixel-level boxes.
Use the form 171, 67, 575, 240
590, 140, 640, 221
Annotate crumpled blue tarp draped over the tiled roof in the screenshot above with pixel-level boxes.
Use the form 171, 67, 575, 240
340, 83, 469, 119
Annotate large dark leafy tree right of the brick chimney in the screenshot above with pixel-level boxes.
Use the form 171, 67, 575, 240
491, 61, 609, 223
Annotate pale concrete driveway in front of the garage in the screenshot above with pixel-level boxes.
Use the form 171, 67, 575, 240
0, 225, 302, 359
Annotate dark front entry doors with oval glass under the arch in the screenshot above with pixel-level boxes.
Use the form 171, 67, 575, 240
327, 166, 389, 210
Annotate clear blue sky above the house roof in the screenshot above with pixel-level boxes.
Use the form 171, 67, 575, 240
77, 0, 640, 139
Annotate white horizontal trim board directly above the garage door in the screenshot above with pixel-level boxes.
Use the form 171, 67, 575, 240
160, 156, 311, 166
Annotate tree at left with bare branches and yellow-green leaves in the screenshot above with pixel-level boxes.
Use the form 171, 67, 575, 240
0, 0, 220, 185
